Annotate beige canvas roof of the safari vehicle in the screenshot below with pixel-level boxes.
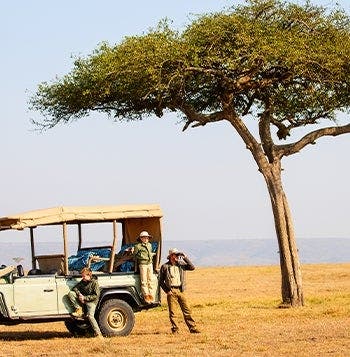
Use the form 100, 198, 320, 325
0, 204, 163, 231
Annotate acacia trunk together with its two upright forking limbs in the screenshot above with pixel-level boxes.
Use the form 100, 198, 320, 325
225, 112, 304, 307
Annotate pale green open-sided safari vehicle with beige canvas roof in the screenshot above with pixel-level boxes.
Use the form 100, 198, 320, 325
0, 205, 162, 336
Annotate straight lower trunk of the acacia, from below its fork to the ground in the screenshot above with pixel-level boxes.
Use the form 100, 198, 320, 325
261, 160, 304, 307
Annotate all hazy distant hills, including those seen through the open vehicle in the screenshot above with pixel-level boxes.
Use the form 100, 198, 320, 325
0, 238, 350, 267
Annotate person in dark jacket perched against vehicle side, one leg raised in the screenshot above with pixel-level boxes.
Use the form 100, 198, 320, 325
68, 268, 102, 337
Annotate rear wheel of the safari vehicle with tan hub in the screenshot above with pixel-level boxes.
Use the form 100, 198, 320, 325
97, 299, 135, 337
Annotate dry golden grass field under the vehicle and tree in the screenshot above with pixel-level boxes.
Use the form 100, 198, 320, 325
0, 263, 350, 357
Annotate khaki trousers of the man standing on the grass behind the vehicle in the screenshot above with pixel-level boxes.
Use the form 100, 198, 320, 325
167, 288, 196, 331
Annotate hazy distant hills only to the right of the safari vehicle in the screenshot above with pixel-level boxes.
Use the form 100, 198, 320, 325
163, 238, 350, 266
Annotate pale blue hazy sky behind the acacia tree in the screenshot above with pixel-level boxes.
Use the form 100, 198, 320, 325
0, 0, 350, 245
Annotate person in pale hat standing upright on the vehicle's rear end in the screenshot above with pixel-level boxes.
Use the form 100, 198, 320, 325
133, 231, 155, 304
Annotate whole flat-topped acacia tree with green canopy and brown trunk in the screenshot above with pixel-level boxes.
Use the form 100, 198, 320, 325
30, 0, 350, 306
